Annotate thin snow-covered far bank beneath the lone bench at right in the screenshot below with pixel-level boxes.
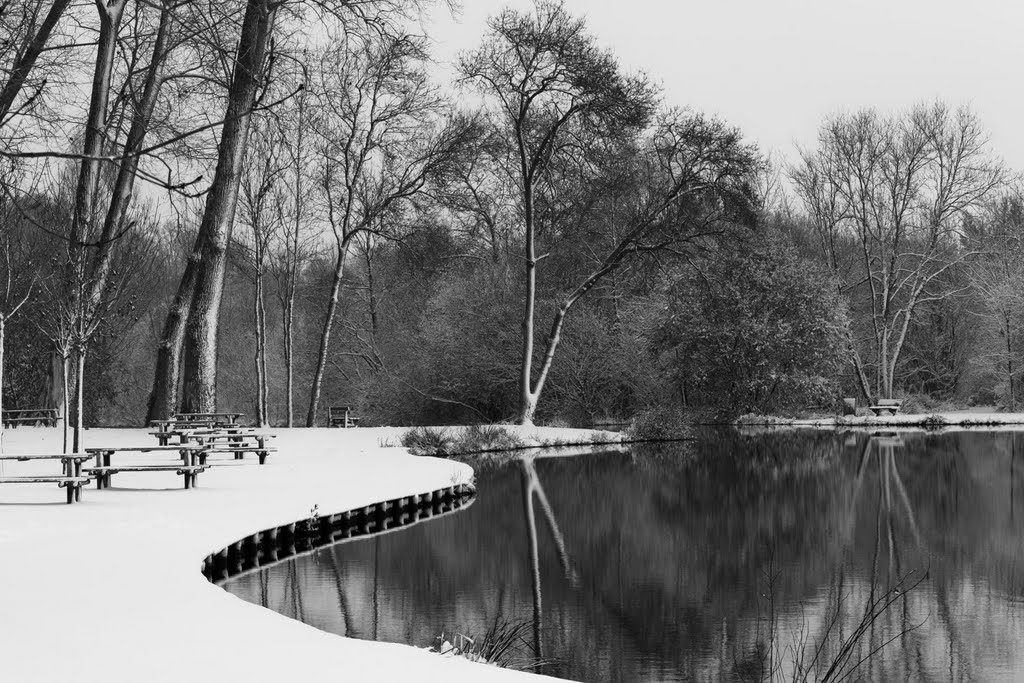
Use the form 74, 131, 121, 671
736, 411, 1024, 429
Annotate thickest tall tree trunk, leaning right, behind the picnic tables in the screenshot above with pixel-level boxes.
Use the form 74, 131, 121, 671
182, 0, 279, 412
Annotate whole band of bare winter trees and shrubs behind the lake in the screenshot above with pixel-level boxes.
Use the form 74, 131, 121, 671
0, 0, 1024, 432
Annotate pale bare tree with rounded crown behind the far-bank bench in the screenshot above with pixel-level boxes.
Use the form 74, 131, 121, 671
792, 102, 1004, 398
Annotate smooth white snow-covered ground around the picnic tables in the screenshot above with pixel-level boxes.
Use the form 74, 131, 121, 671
0, 427, 598, 683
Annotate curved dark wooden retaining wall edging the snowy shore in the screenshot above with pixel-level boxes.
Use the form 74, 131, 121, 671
203, 484, 476, 584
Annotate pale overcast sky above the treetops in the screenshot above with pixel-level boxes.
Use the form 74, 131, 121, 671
421, 0, 1024, 170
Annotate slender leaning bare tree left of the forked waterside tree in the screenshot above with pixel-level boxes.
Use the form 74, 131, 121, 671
306, 33, 470, 427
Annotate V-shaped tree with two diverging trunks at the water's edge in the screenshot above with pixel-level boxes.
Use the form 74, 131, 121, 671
460, 1, 754, 424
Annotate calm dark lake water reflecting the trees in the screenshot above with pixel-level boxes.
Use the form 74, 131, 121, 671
225, 432, 1024, 681
